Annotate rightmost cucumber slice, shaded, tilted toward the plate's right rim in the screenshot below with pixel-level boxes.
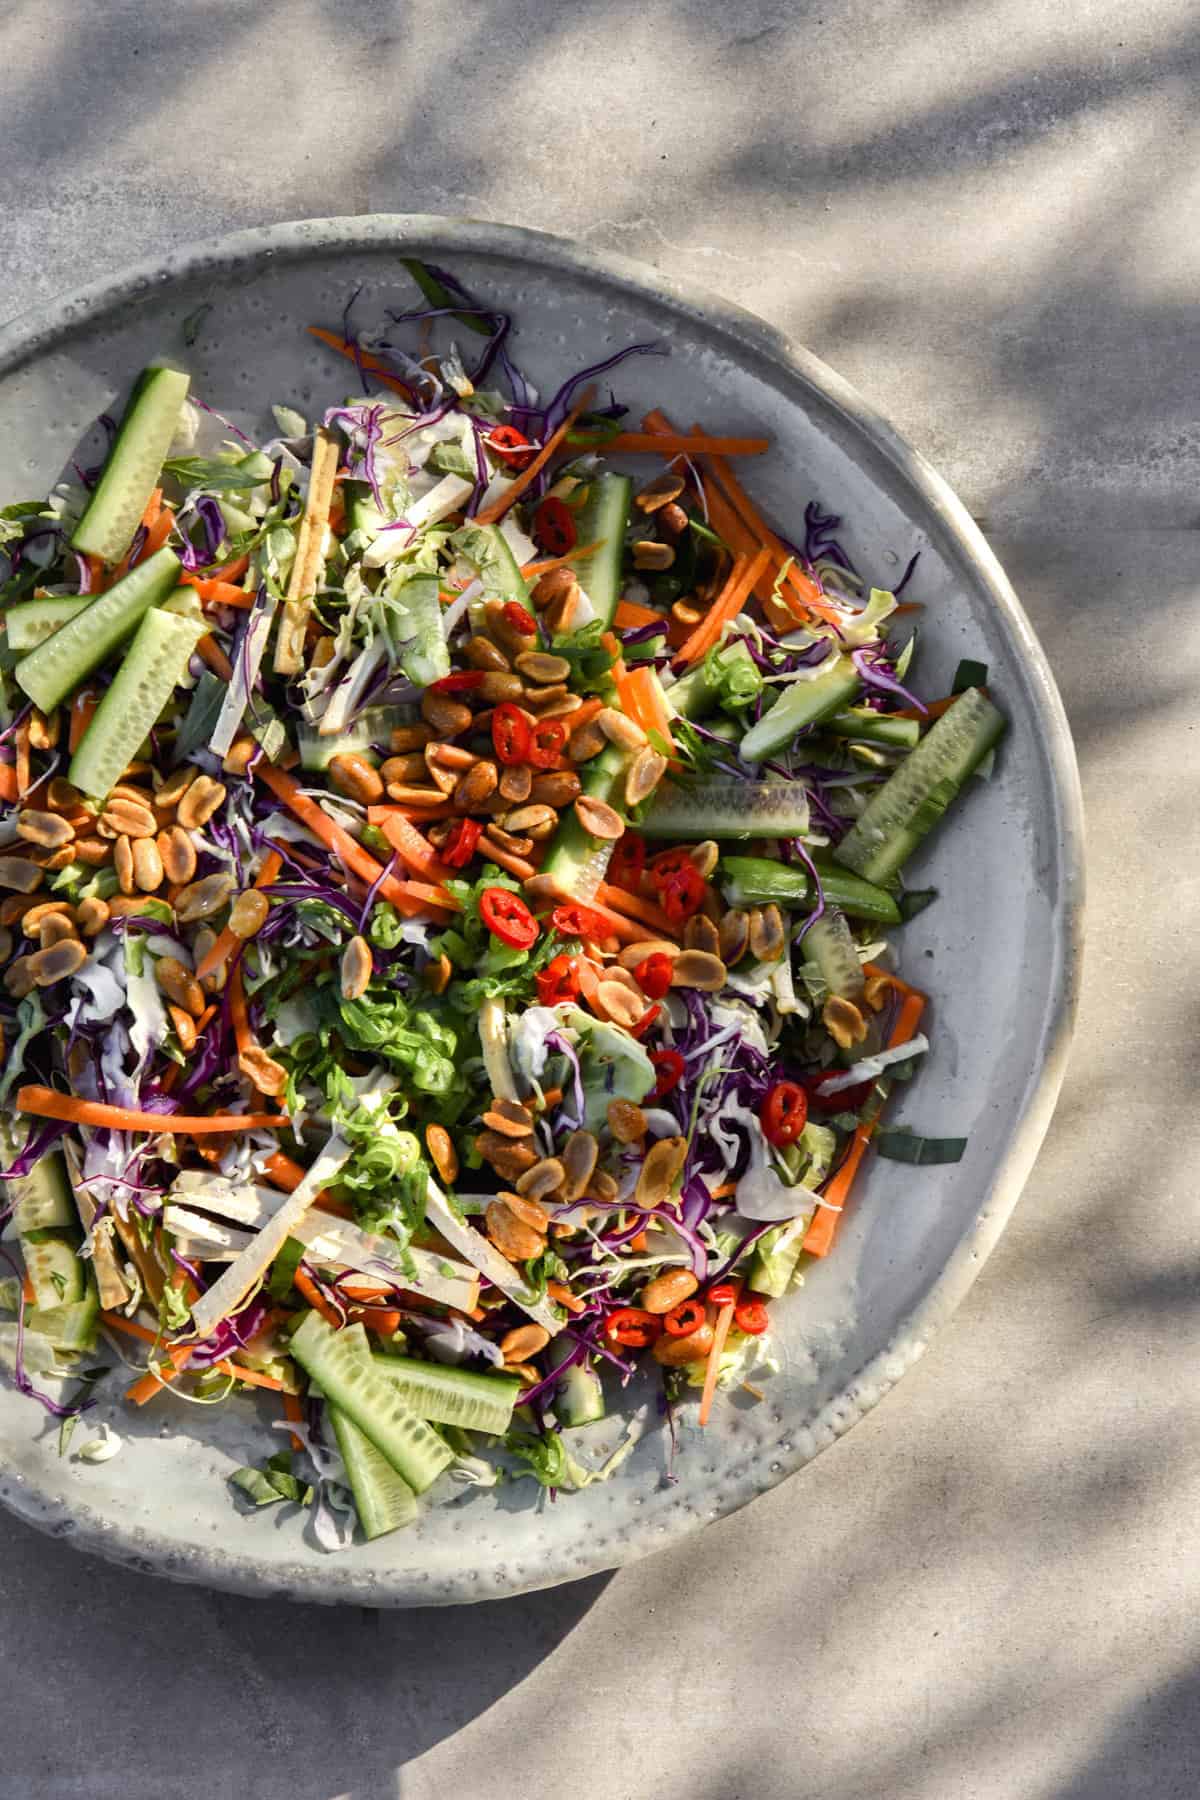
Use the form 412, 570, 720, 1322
831, 687, 1007, 882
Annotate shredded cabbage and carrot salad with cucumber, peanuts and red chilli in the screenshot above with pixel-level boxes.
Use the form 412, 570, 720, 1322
0, 263, 1004, 1544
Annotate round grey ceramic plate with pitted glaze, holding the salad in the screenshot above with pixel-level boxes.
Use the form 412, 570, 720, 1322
0, 216, 1081, 1606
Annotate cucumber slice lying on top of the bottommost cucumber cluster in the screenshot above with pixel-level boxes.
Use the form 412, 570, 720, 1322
290, 1312, 453, 1494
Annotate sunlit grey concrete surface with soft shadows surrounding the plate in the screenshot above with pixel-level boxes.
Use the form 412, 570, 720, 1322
0, 0, 1200, 1800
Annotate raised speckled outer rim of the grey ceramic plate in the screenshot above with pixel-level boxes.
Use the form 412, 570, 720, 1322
0, 212, 1085, 1606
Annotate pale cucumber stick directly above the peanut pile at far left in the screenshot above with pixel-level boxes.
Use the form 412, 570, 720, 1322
68, 607, 207, 799
